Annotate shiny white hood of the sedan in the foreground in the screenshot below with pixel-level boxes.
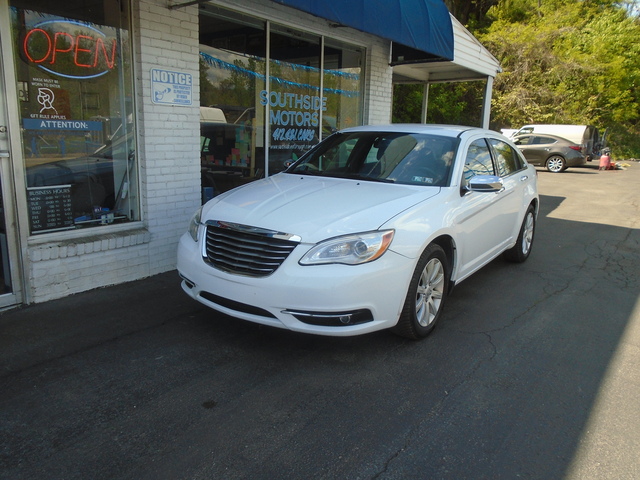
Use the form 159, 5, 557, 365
202, 173, 441, 243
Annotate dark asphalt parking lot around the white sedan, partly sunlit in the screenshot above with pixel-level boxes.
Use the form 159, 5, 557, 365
0, 163, 640, 479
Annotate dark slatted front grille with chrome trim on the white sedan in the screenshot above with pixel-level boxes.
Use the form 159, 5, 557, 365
203, 220, 300, 277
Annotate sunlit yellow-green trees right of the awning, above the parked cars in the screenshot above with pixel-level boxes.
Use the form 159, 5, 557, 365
475, 0, 640, 157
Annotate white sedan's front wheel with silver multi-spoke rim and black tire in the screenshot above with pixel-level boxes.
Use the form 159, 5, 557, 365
392, 244, 450, 340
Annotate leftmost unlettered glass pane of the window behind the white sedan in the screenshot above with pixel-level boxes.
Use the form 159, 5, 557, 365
200, 5, 266, 197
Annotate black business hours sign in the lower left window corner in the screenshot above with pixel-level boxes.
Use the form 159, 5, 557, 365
27, 185, 73, 233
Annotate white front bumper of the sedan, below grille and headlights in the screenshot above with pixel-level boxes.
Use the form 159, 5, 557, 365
178, 234, 415, 336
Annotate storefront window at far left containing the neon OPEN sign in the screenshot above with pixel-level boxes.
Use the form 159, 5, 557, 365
10, 0, 140, 234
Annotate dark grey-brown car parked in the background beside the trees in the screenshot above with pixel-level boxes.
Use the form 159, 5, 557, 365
513, 134, 587, 173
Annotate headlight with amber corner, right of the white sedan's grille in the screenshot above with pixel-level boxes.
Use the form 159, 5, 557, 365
299, 230, 394, 265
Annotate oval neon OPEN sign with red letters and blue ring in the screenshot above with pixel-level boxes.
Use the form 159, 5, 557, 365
22, 20, 117, 79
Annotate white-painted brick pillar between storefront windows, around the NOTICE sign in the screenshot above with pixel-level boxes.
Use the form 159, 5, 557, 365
134, 0, 200, 275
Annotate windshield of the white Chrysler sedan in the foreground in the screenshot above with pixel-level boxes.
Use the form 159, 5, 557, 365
286, 132, 458, 187
